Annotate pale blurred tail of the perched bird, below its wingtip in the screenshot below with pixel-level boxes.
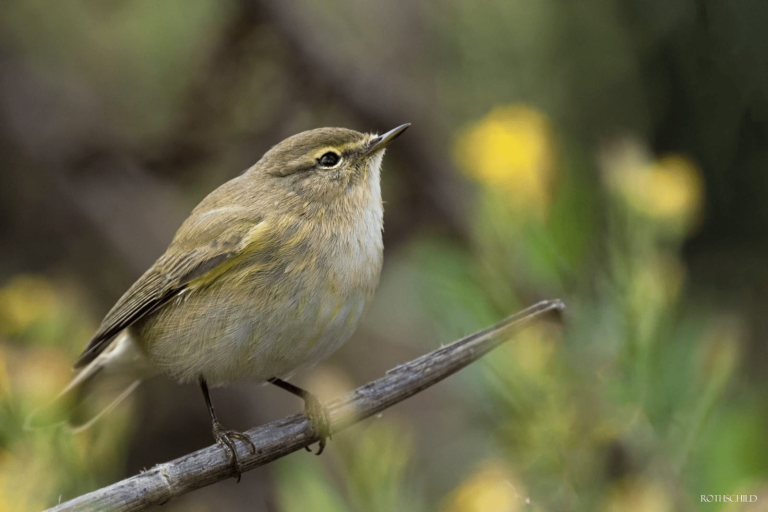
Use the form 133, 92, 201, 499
24, 331, 155, 432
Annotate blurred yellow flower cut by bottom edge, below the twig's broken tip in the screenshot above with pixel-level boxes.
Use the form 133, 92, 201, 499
443, 460, 528, 512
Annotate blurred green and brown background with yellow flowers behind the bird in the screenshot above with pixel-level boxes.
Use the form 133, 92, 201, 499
0, 0, 768, 512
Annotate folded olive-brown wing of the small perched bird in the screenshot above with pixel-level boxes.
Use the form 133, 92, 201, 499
74, 208, 266, 369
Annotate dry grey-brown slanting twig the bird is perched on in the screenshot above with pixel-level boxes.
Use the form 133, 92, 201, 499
47, 300, 565, 512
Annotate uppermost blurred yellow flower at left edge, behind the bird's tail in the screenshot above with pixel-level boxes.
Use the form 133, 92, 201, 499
0, 275, 59, 334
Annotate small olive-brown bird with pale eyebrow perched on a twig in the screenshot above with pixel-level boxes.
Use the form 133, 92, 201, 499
37, 124, 410, 481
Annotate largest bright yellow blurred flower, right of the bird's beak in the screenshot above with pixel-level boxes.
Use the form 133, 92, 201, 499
456, 104, 554, 214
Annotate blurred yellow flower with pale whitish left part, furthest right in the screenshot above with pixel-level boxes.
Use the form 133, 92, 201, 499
601, 139, 704, 228
